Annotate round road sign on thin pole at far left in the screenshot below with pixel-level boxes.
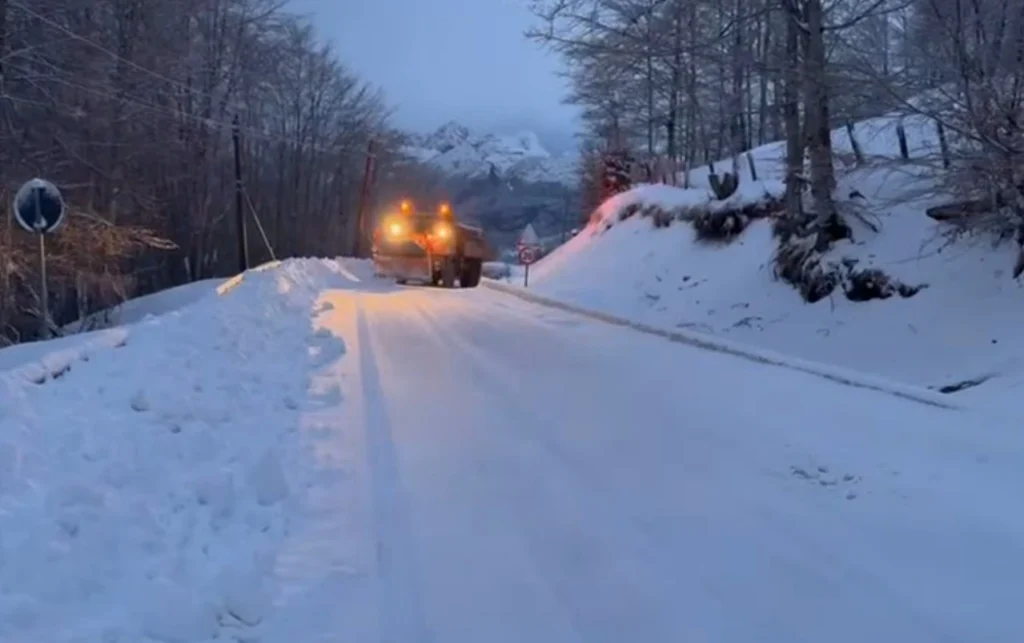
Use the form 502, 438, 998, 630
11, 178, 68, 339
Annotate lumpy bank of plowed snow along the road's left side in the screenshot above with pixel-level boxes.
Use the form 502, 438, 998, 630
0, 256, 337, 643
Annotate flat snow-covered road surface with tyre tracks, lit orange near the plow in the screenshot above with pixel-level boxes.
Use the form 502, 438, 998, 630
271, 262, 1024, 643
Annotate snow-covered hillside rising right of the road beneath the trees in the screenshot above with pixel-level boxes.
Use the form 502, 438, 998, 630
512, 111, 1024, 406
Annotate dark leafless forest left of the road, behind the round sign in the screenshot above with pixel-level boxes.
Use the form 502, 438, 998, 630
0, 0, 436, 344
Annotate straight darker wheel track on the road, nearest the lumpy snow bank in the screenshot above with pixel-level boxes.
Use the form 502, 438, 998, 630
356, 306, 433, 643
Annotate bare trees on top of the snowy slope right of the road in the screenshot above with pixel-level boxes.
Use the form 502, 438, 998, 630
527, 0, 1024, 274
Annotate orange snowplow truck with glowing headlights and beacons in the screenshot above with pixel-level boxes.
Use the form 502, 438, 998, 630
373, 201, 489, 288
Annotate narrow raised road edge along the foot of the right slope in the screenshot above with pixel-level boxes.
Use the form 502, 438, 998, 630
480, 280, 968, 411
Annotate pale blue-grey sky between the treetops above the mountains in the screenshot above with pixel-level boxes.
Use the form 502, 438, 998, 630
292, 0, 574, 149
